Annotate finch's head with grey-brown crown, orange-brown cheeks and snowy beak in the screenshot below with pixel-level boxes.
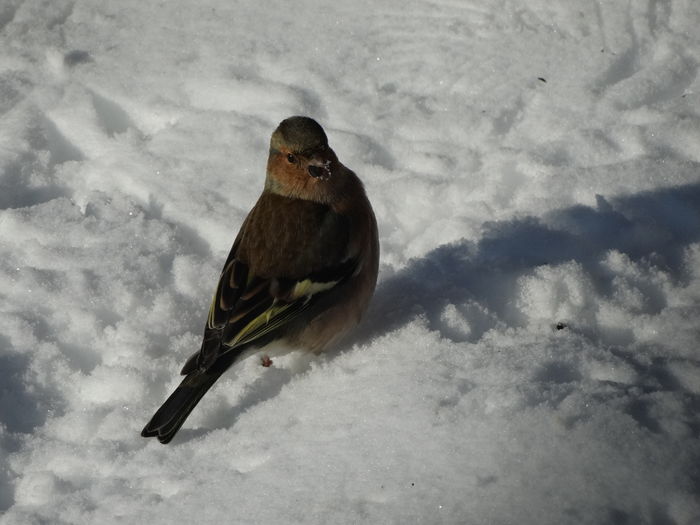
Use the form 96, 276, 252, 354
265, 116, 342, 202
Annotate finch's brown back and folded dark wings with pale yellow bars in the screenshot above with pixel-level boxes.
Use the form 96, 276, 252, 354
196, 193, 360, 370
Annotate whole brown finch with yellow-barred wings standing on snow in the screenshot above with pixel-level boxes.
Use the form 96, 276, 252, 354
141, 116, 379, 444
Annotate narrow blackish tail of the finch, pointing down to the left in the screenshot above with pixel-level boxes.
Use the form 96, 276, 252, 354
141, 370, 223, 444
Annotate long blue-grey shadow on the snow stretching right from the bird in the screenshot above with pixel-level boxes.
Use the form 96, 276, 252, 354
176, 180, 700, 442
